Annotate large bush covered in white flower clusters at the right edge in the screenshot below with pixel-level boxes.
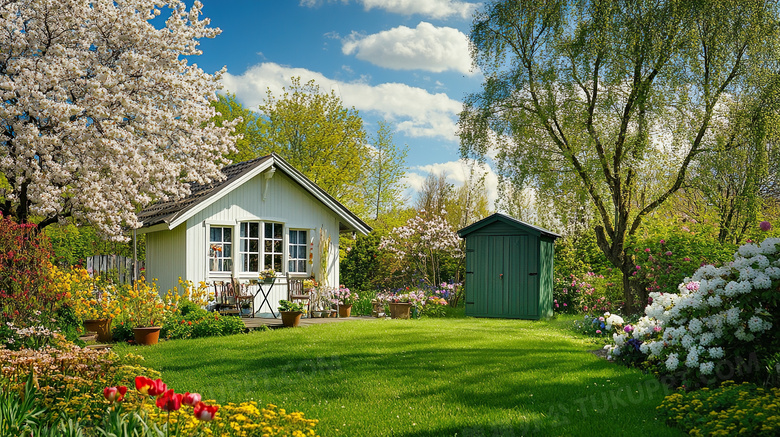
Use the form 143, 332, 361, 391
609, 238, 780, 387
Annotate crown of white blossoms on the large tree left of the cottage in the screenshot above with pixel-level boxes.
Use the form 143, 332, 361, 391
0, 0, 235, 239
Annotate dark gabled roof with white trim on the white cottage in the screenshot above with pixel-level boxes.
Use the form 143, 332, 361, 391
137, 153, 371, 234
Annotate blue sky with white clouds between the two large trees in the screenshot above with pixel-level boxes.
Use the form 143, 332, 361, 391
188, 0, 495, 204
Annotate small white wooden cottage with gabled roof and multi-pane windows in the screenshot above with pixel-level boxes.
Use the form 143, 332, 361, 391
138, 154, 371, 313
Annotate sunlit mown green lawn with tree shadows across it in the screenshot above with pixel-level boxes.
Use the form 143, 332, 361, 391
117, 318, 683, 437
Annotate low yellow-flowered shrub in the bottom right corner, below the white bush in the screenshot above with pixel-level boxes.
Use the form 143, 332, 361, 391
658, 381, 780, 436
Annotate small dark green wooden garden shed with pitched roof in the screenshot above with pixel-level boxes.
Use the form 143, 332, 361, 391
458, 213, 560, 320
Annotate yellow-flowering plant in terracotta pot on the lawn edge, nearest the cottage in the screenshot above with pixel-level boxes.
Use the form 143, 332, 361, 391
122, 278, 179, 345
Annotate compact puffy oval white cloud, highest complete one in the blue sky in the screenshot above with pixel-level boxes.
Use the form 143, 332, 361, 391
341, 21, 473, 74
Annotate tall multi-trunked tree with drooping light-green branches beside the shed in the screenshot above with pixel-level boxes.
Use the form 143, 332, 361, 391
459, 0, 778, 310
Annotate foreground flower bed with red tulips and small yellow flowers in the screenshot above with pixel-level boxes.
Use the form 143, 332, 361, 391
0, 333, 317, 436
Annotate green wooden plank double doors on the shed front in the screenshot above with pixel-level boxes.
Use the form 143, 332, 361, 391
466, 235, 539, 318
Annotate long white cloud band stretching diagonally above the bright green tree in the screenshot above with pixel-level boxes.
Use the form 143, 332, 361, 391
222, 62, 463, 141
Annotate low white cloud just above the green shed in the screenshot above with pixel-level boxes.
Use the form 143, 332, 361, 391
404, 159, 498, 208
